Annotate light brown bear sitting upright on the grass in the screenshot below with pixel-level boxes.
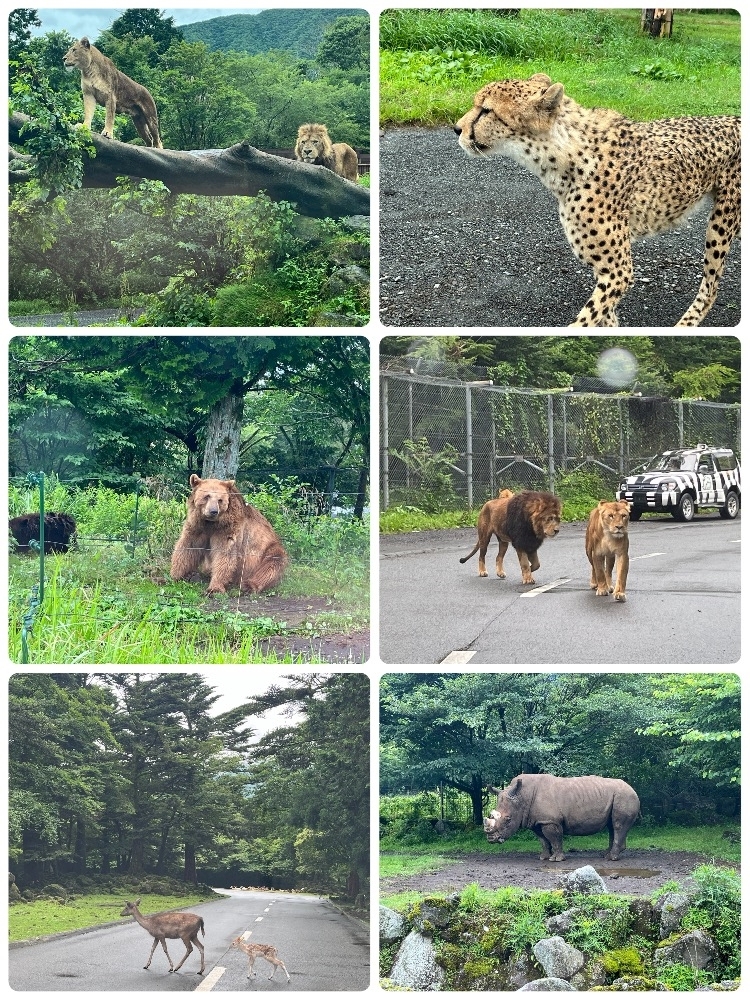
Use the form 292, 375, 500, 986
170, 475, 289, 594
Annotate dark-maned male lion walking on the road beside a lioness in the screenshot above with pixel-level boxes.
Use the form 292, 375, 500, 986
459, 490, 562, 584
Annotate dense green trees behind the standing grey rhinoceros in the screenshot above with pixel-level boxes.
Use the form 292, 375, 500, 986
380, 673, 740, 826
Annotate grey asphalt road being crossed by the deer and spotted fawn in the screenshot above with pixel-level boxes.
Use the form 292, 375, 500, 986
9, 889, 370, 993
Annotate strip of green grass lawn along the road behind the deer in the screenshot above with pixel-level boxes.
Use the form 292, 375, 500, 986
8, 893, 220, 941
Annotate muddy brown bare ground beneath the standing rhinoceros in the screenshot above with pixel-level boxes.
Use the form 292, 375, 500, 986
380, 848, 739, 896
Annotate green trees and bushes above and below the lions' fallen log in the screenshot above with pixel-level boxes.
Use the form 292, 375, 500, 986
5, 9, 370, 316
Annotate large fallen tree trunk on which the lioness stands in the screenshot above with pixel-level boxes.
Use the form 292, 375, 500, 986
10, 112, 370, 219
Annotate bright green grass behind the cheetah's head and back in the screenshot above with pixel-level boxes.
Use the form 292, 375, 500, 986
380, 9, 740, 125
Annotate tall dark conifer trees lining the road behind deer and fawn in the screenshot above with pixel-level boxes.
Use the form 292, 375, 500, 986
9, 673, 370, 894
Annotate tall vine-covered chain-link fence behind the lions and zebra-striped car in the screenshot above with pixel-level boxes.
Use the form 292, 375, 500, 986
380, 371, 741, 510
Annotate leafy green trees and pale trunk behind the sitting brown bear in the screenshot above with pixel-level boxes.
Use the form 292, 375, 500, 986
9, 336, 370, 500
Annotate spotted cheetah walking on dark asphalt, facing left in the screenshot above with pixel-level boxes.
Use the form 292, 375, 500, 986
455, 73, 740, 326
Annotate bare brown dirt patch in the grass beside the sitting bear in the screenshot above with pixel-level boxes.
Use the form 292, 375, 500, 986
212, 594, 370, 664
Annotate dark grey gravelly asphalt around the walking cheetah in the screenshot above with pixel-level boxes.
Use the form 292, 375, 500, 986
380, 126, 740, 327
